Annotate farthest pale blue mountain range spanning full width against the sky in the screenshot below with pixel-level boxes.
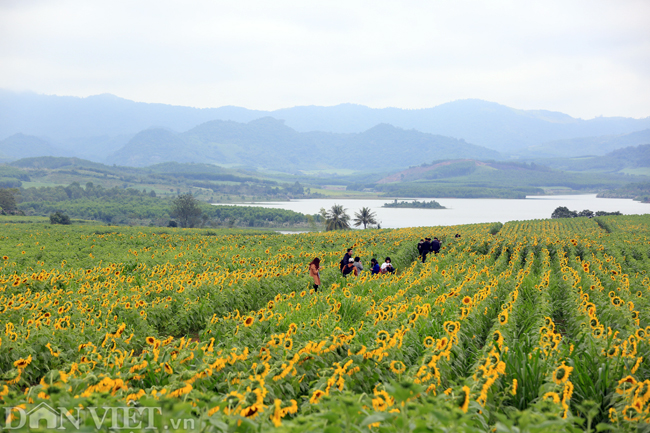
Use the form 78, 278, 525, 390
0, 90, 650, 159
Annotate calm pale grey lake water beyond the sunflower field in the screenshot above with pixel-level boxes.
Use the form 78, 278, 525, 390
215, 194, 650, 228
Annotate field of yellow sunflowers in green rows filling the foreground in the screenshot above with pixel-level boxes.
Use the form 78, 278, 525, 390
0, 215, 650, 432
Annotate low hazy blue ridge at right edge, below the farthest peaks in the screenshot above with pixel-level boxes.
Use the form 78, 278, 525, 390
520, 129, 650, 158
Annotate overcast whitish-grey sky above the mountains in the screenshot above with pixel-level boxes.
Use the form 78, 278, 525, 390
0, 0, 650, 119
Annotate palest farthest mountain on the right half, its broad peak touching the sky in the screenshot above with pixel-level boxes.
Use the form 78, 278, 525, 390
273, 99, 650, 152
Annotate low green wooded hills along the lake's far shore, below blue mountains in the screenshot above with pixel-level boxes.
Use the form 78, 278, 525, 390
0, 153, 650, 208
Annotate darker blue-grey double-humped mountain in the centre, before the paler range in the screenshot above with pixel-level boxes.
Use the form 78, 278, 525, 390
107, 117, 500, 171
